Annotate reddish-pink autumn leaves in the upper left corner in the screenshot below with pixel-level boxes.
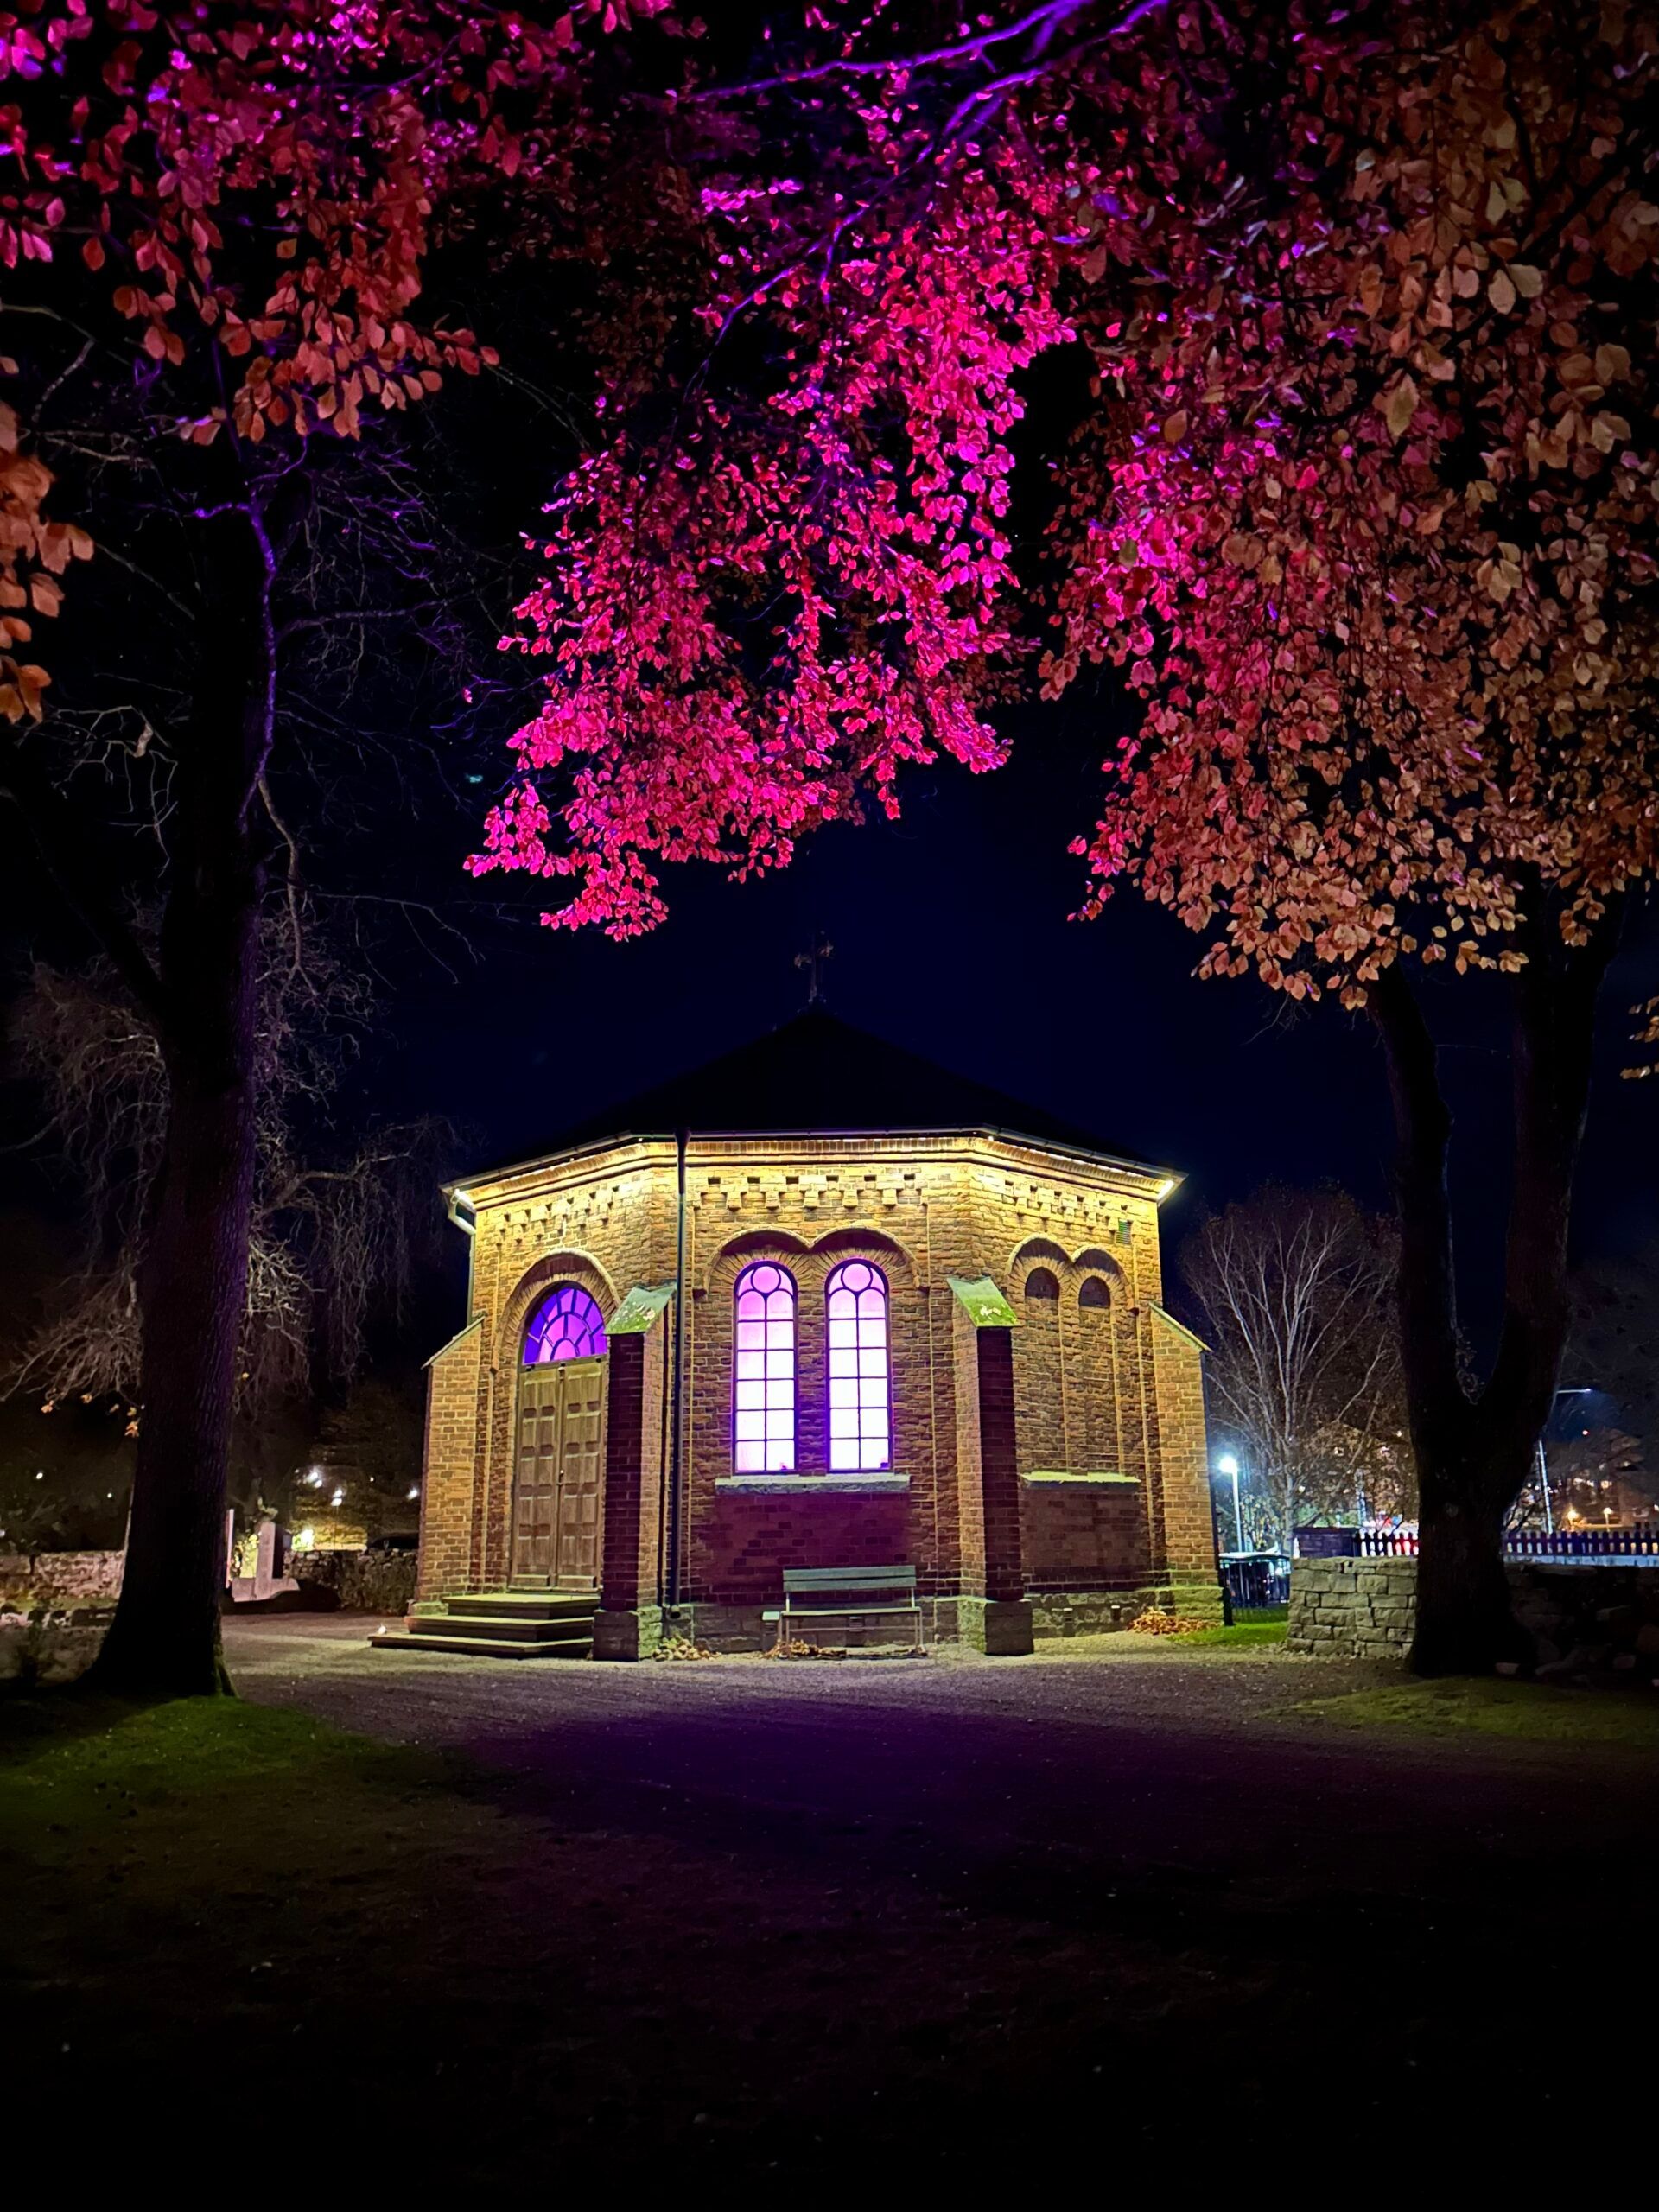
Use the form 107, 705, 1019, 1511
0, 0, 666, 721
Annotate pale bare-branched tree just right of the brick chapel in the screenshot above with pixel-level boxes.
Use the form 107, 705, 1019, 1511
1177, 1184, 1409, 1548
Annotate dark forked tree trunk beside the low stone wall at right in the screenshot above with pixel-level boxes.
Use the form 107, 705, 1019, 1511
1370, 911, 1619, 1675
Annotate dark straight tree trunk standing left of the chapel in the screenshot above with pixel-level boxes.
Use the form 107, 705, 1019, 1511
91, 505, 274, 1697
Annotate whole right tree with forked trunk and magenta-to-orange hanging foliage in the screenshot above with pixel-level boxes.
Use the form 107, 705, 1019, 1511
475, 0, 1659, 1672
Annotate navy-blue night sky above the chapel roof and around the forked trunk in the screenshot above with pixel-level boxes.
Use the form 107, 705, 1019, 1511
353, 668, 1659, 1330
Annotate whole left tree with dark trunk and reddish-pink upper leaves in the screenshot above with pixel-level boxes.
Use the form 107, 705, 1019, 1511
0, 0, 659, 1694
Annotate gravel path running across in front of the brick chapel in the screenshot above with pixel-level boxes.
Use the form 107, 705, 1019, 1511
228, 1615, 1655, 1896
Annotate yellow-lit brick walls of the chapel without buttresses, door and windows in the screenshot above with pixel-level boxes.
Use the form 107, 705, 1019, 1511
420, 1135, 1214, 1604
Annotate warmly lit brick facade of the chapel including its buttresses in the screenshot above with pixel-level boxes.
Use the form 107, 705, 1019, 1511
420, 1061, 1219, 1656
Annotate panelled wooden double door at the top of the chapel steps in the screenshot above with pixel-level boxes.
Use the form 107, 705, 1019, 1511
513, 1360, 604, 1591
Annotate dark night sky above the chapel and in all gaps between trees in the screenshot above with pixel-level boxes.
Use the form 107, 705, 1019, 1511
0, 190, 1659, 1351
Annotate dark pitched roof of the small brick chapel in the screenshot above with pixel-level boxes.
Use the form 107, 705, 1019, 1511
477, 1007, 1137, 1161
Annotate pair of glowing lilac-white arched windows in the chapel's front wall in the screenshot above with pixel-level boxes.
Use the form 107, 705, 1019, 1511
732, 1259, 893, 1476
